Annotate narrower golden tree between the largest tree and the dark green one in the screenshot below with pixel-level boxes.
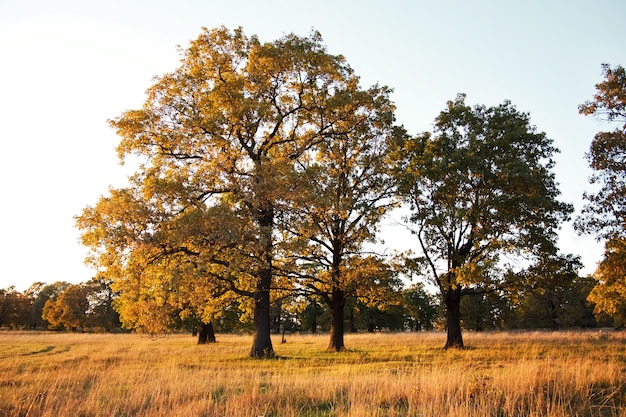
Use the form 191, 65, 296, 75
284, 83, 404, 351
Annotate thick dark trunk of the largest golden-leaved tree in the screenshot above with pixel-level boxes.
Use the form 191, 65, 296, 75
250, 269, 274, 359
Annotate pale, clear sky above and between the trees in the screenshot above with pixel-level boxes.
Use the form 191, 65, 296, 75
0, 0, 626, 290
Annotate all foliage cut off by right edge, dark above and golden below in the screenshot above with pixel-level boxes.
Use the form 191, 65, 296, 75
575, 64, 626, 325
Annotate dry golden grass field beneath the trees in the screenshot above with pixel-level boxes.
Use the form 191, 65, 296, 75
0, 331, 626, 417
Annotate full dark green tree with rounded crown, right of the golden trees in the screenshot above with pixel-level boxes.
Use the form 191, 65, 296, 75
397, 95, 573, 348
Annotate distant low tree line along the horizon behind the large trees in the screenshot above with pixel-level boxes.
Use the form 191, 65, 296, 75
0, 276, 608, 334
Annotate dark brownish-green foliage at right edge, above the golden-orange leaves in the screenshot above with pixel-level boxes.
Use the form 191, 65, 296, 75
575, 64, 626, 239
